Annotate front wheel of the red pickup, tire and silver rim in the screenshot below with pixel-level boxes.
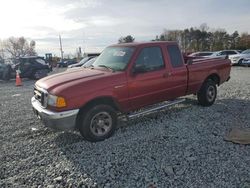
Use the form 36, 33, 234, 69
79, 104, 117, 142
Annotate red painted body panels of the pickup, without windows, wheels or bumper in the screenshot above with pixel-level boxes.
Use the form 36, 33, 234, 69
36, 42, 231, 112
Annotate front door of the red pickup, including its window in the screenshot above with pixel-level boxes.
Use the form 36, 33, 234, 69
128, 46, 169, 109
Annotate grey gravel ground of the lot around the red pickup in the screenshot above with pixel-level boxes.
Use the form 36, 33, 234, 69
0, 67, 250, 188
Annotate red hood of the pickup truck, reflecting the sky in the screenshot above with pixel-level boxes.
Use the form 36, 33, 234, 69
36, 68, 106, 90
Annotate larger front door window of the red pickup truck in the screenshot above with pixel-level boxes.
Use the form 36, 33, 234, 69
134, 47, 164, 72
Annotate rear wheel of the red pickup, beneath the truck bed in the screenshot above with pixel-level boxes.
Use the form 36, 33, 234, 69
197, 79, 217, 106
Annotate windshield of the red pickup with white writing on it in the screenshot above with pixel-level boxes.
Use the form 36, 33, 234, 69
93, 47, 134, 71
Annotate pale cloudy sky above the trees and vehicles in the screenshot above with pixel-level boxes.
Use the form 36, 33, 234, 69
0, 0, 250, 55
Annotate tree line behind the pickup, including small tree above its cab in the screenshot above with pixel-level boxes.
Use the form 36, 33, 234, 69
118, 24, 250, 52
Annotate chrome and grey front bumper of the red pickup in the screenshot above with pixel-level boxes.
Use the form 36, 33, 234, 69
31, 97, 79, 130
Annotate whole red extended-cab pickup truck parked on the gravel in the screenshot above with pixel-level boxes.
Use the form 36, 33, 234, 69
31, 42, 231, 141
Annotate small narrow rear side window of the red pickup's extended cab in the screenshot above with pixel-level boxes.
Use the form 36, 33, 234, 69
167, 45, 183, 67
